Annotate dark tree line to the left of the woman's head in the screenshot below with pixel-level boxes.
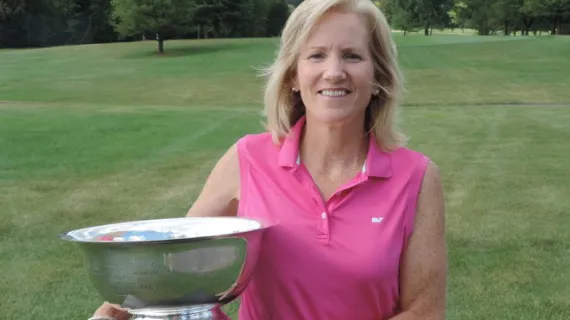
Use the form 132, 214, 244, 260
0, 0, 294, 52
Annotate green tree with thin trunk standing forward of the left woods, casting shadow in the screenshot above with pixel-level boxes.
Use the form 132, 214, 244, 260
111, 0, 196, 54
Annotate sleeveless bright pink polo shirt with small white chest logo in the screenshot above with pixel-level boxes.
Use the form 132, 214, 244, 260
234, 118, 428, 320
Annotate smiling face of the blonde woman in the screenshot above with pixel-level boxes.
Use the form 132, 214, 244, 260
293, 12, 374, 124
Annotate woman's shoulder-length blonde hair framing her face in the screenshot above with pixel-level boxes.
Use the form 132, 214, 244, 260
264, 0, 405, 151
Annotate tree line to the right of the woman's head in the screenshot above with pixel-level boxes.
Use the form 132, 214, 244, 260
382, 0, 570, 36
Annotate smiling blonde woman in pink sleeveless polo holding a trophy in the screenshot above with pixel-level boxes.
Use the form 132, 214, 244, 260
90, 0, 446, 320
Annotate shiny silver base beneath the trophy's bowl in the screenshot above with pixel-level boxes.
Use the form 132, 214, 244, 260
129, 305, 230, 320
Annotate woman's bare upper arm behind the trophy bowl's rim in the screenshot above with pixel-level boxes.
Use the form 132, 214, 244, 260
186, 144, 240, 217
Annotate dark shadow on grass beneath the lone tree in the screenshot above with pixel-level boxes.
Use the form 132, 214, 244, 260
123, 41, 250, 59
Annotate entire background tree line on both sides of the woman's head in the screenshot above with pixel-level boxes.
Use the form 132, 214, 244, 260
0, 0, 570, 52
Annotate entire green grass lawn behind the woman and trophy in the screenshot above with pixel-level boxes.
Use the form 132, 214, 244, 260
0, 35, 570, 320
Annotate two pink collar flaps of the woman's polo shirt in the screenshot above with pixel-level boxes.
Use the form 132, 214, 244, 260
278, 116, 392, 178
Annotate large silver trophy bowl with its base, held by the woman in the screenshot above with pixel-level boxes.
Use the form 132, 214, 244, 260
61, 217, 272, 320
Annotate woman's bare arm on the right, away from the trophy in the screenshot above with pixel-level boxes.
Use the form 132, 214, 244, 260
391, 163, 447, 320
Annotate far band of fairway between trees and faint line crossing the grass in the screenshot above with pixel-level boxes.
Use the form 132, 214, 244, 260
0, 34, 570, 108
